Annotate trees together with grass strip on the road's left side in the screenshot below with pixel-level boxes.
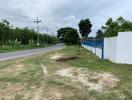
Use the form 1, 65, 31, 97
0, 20, 58, 52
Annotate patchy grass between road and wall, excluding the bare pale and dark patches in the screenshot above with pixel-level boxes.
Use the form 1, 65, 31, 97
0, 46, 132, 100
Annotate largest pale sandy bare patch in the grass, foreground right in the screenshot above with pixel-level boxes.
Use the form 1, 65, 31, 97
56, 68, 119, 92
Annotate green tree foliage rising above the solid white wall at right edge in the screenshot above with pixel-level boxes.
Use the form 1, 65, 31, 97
102, 17, 132, 37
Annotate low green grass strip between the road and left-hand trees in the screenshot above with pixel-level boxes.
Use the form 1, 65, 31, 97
0, 44, 51, 53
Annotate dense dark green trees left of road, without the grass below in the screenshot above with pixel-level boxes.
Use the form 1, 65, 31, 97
0, 20, 58, 45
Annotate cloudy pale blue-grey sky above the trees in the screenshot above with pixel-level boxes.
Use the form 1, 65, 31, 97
0, 0, 132, 36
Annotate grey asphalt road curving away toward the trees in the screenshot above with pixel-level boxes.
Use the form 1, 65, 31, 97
0, 44, 64, 61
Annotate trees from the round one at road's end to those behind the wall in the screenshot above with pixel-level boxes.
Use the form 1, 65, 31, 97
57, 17, 132, 44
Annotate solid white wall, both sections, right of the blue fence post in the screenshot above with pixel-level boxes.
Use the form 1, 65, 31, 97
104, 32, 132, 64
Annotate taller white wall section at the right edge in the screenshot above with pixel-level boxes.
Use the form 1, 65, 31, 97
116, 32, 132, 64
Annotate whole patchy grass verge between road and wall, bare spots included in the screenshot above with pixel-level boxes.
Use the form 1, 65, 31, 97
0, 46, 132, 100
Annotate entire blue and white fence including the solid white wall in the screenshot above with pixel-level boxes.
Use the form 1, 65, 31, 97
82, 32, 132, 64
